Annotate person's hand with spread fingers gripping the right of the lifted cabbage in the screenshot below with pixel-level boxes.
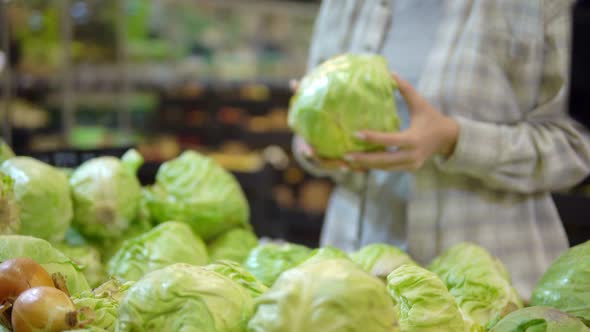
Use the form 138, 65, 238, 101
345, 74, 459, 171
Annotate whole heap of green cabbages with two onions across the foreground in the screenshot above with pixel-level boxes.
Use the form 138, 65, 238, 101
0, 146, 590, 332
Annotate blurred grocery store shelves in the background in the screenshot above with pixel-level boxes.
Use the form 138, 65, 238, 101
0, 0, 590, 246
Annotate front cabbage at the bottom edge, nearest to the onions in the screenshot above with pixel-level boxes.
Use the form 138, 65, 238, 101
117, 264, 254, 332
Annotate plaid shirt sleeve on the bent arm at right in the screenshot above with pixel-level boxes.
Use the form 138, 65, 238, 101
436, 1, 590, 193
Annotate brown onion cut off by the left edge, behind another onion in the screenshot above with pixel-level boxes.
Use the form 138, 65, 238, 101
0, 257, 55, 303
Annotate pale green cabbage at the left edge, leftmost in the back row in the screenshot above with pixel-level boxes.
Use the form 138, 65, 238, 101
0, 157, 73, 242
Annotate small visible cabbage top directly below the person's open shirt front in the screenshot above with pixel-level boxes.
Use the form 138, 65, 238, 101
350, 243, 416, 280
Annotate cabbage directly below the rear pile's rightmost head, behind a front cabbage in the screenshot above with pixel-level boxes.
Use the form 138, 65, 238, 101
108, 221, 208, 280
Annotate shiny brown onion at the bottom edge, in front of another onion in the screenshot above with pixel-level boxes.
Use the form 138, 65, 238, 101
12, 286, 77, 332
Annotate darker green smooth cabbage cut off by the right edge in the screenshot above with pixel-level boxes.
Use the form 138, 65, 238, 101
531, 241, 590, 326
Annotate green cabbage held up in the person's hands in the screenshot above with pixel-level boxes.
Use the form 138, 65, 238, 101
288, 54, 400, 158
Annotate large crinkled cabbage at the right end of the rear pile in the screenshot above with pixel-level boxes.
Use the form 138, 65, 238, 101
148, 151, 250, 241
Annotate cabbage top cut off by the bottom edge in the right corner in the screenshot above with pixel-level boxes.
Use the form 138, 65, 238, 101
490, 307, 590, 332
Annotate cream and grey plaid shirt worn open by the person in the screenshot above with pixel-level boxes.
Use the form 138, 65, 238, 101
298, 0, 590, 298
